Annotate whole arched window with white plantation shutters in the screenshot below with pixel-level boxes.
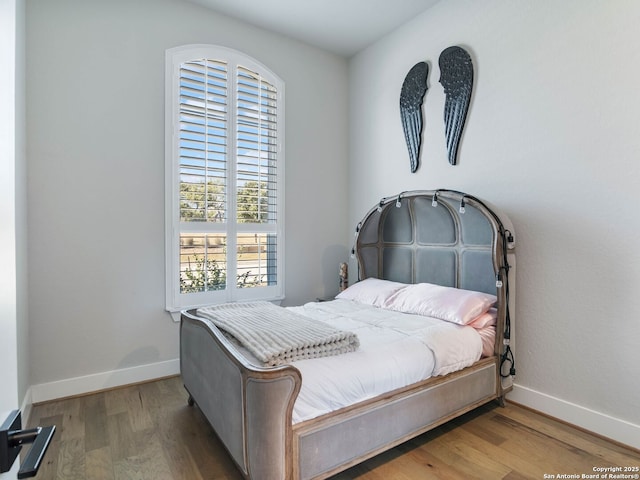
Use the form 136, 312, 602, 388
166, 46, 284, 311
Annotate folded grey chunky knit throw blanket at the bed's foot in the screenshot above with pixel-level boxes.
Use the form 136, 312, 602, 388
197, 302, 360, 366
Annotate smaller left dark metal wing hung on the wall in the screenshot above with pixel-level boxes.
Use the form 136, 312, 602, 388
400, 62, 429, 173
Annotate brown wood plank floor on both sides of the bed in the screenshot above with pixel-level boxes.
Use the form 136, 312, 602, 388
30, 377, 640, 480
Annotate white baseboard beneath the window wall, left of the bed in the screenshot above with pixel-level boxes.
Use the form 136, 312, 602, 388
29, 358, 180, 403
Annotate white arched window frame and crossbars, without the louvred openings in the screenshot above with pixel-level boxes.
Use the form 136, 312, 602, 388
165, 44, 285, 313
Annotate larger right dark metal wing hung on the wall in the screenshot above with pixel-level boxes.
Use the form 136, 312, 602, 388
438, 46, 473, 165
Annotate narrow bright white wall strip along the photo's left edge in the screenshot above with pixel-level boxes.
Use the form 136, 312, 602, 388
0, 0, 29, 428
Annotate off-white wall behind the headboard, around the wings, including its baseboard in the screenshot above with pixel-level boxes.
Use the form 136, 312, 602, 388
349, 0, 640, 447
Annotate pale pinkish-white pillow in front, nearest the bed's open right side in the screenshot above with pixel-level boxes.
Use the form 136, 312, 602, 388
383, 283, 497, 325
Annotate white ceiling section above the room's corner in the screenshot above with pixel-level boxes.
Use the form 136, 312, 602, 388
191, 0, 439, 57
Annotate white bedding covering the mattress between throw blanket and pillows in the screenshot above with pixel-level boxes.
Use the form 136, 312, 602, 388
288, 300, 482, 423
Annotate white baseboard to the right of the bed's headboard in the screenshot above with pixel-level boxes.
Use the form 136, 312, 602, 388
507, 384, 640, 449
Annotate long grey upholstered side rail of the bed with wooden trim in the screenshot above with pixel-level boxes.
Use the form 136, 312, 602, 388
293, 357, 498, 479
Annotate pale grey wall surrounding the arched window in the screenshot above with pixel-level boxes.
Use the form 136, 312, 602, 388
27, 0, 349, 394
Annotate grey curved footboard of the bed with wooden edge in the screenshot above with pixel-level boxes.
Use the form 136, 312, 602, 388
180, 312, 301, 480
